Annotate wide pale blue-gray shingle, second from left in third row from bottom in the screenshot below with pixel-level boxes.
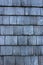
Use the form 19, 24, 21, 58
5, 36, 17, 45
